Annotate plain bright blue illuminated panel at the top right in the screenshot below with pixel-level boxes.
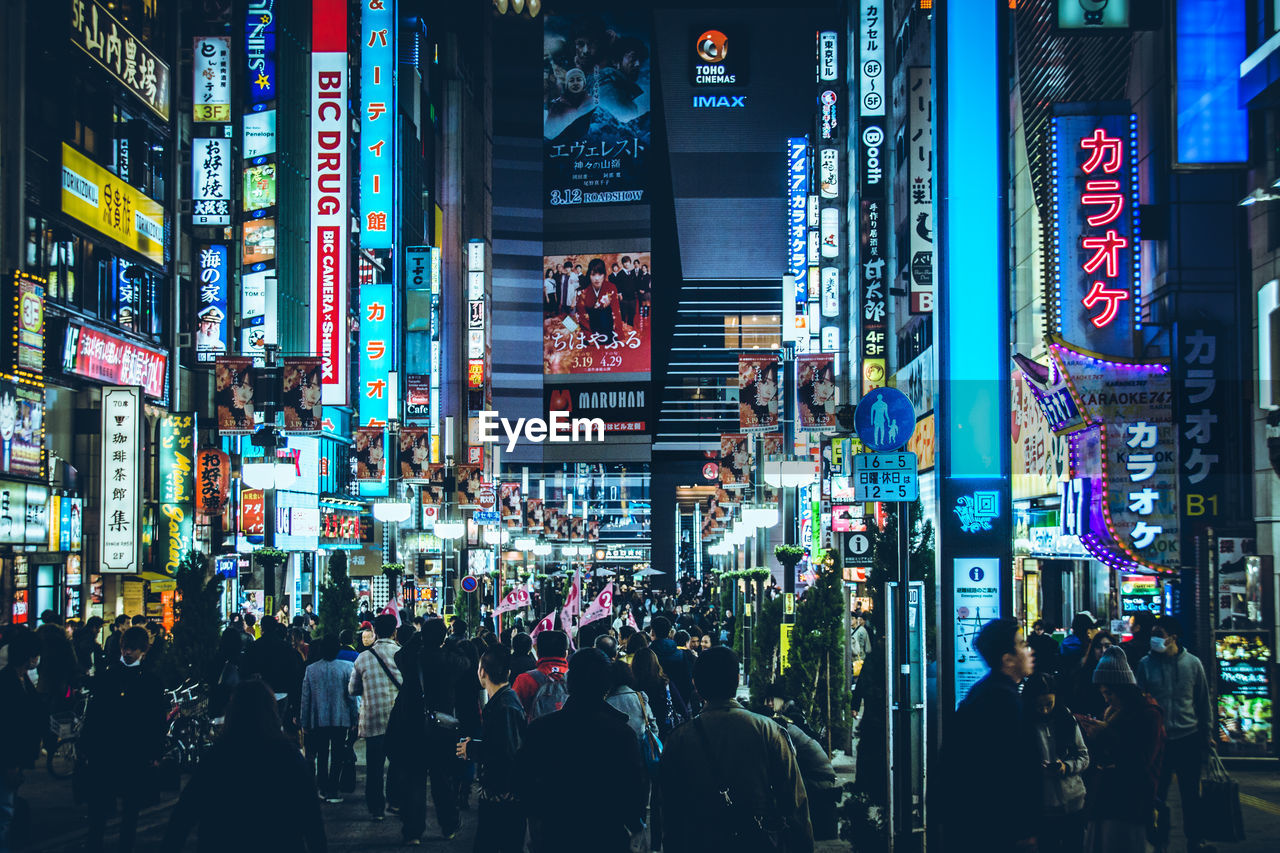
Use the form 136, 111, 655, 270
1174, 0, 1249, 164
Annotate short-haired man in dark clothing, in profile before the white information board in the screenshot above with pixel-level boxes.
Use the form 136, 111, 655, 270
943, 617, 1039, 853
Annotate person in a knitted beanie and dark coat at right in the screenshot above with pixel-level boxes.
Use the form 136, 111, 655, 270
1078, 646, 1165, 853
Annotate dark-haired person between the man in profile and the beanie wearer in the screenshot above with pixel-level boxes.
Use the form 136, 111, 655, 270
1023, 672, 1097, 853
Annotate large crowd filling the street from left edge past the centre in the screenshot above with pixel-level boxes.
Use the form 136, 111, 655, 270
0, 578, 838, 853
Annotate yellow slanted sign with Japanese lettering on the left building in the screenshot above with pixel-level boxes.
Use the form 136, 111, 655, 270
63, 142, 164, 264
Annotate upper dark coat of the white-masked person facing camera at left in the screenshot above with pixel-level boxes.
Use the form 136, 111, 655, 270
79, 661, 169, 774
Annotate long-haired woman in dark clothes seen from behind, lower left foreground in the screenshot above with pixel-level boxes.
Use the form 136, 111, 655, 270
163, 679, 326, 853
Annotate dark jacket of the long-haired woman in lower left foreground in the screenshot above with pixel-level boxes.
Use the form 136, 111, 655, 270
161, 738, 326, 853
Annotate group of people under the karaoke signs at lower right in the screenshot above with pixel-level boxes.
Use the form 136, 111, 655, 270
943, 612, 1215, 853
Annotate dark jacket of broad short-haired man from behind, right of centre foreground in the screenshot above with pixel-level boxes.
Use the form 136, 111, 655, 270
660, 699, 813, 853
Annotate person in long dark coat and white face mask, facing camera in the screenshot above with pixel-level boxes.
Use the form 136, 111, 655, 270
79, 625, 169, 853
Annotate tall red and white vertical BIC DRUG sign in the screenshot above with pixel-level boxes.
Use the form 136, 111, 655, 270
310, 0, 351, 406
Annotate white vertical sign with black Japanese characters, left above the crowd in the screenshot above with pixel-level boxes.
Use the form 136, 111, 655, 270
99, 386, 142, 573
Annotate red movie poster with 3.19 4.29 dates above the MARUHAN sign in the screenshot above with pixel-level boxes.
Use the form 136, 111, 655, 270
543, 252, 653, 375
